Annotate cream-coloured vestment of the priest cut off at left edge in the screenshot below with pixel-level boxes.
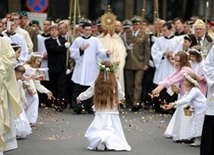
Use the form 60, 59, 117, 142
0, 37, 21, 154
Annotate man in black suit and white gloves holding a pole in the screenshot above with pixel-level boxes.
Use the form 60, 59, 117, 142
45, 25, 70, 111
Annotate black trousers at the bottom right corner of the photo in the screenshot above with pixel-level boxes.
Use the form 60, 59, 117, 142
200, 115, 214, 155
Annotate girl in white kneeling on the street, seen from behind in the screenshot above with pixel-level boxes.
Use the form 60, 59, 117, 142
77, 61, 131, 151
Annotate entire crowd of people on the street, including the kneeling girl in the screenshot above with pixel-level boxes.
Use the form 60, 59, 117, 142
0, 11, 214, 155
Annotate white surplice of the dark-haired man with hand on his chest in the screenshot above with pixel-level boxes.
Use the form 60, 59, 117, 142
70, 36, 107, 86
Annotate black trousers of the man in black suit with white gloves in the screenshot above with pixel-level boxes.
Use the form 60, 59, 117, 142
49, 70, 66, 100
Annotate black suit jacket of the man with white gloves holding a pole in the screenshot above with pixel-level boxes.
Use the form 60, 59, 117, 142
45, 36, 67, 73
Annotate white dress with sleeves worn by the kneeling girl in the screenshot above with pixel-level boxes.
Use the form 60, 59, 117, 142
79, 82, 131, 151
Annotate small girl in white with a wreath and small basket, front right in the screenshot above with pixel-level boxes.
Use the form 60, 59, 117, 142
163, 73, 206, 146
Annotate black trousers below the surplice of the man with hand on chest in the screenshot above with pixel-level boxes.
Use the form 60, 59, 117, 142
72, 83, 93, 111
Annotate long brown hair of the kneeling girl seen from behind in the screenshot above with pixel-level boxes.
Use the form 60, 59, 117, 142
93, 61, 118, 110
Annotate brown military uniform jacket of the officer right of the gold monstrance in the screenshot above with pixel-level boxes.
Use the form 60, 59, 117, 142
124, 30, 150, 70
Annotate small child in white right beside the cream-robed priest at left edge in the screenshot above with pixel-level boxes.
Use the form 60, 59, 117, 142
15, 65, 32, 138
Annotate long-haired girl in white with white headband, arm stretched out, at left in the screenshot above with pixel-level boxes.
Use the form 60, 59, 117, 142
23, 52, 53, 126
